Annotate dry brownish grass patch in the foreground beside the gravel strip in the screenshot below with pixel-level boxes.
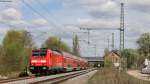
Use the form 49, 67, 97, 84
88, 68, 150, 84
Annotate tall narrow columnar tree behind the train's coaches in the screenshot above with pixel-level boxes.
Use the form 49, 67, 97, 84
72, 35, 80, 56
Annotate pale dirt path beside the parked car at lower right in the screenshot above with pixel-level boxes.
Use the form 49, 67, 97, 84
127, 70, 150, 81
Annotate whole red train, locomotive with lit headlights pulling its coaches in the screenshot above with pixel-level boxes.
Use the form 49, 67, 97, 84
30, 48, 88, 74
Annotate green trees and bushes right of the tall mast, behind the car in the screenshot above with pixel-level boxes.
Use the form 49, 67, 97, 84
121, 33, 150, 68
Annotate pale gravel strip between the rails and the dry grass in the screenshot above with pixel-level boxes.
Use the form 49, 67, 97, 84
59, 70, 97, 84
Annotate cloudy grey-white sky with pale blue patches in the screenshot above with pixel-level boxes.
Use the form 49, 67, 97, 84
0, 0, 150, 56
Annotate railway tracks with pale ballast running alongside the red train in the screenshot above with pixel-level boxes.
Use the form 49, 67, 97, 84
0, 69, 95, 84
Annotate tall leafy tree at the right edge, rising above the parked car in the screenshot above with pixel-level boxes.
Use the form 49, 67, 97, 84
137, 33, 150, 59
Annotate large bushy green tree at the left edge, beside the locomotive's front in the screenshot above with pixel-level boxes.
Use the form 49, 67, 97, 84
1, 30, 33, 72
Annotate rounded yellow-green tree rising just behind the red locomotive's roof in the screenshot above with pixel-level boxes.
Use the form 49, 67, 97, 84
42, 36, 71, 52
